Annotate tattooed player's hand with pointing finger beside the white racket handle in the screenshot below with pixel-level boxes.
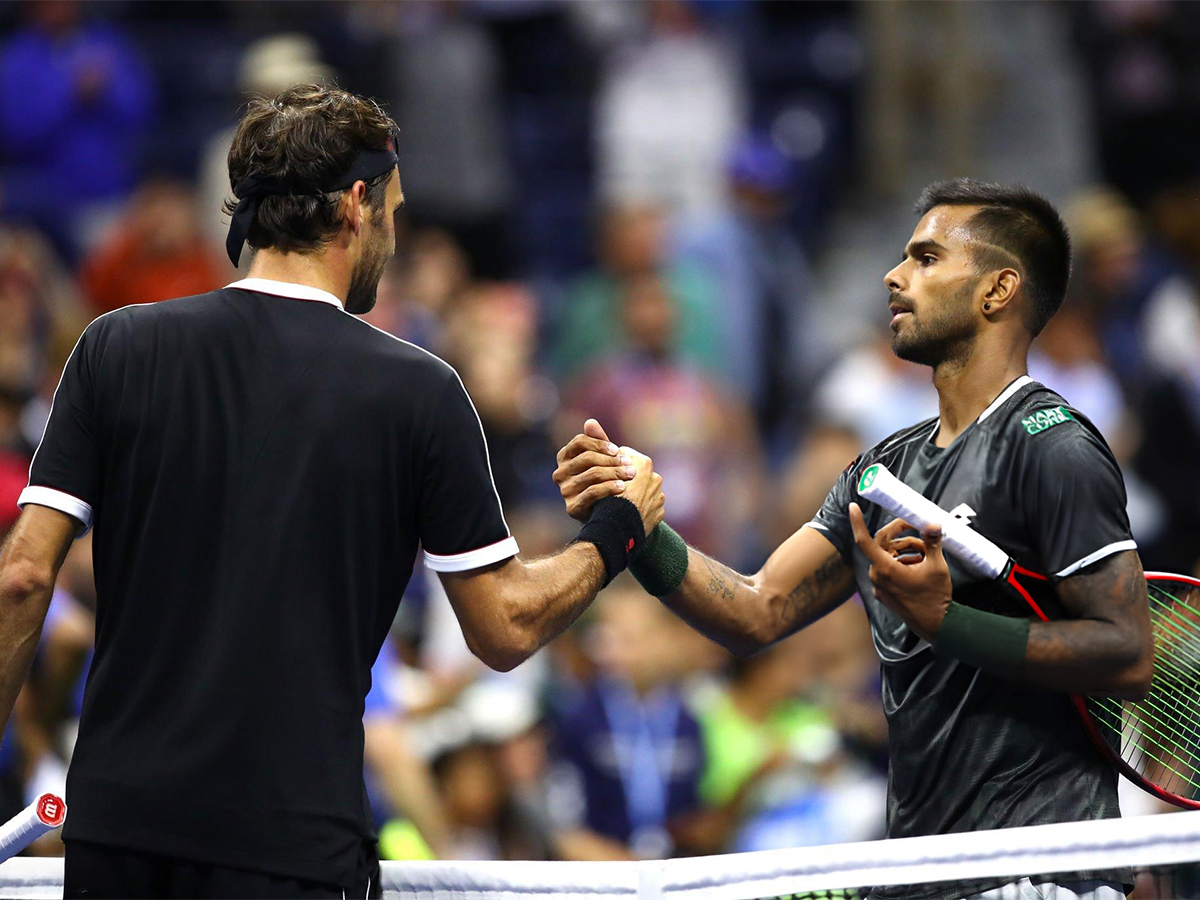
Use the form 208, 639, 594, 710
850, 503, 953, 643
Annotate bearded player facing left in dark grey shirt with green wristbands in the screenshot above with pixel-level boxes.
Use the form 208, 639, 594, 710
559, 180, 1153, 900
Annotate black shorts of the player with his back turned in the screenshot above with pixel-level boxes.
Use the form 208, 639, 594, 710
62, 841, 383, 900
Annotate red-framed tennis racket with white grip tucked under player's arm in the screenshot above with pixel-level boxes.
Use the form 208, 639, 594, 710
858, 463, 1200, 809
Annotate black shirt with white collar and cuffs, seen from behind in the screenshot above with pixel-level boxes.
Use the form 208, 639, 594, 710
20, 278, 517, 883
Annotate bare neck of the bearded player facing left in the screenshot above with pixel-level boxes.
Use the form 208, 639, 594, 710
934, 342, 1028, 448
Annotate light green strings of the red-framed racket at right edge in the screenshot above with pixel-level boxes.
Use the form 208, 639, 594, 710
1087, 581, 1200, 799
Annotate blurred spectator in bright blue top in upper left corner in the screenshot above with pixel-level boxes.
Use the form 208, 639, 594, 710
0, 0, 155, 256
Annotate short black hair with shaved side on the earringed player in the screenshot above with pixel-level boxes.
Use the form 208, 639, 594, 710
917, 178, 1070, 336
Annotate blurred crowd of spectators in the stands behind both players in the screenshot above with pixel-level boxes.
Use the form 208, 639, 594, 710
0, 0, 1200, 859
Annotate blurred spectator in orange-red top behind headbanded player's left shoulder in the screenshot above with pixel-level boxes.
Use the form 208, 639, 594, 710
82, 180, 224, 313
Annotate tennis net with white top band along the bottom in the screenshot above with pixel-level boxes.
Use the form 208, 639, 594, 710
0, 811, 1200, 900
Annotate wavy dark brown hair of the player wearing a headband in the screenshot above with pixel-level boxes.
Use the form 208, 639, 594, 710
223, 84, 396, 252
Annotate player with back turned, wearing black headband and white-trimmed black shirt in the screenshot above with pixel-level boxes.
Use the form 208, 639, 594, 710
0, 85, 662, 898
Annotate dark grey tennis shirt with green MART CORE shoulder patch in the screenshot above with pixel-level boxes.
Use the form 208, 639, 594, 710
810, 377, 1136, 897
